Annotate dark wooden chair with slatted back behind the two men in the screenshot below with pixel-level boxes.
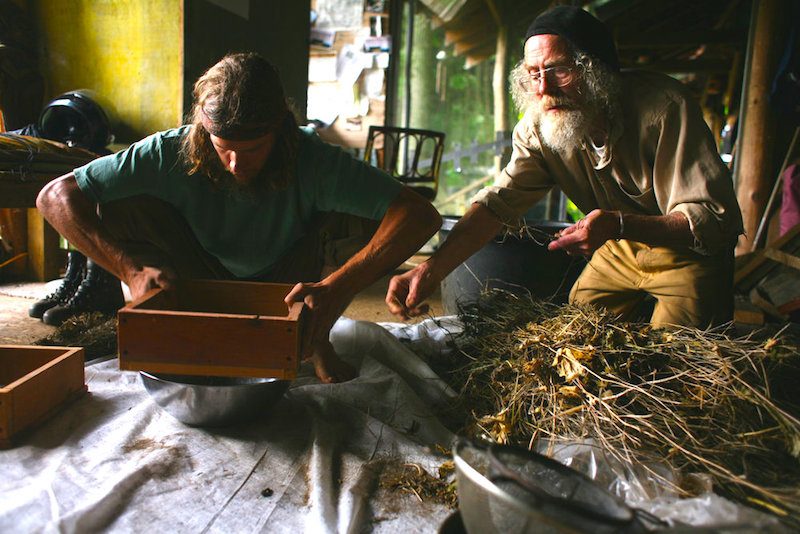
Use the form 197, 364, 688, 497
364, 126, 444, 201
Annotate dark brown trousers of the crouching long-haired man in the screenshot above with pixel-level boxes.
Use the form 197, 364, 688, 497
100, 195, 379, 284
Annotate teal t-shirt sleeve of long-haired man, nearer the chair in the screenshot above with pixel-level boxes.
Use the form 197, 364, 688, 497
311, 137, 403, 220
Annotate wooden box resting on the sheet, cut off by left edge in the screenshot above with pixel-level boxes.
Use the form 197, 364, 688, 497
0, 345, 86, 449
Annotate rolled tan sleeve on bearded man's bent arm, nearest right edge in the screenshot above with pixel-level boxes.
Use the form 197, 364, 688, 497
653, 91, 742, 255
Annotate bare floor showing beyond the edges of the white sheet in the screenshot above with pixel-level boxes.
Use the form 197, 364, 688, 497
0, 276, 443, 345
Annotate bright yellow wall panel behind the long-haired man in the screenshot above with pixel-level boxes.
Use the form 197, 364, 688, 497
30, 0, 183, 142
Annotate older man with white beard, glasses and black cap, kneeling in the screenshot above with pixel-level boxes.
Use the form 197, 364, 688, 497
386, 6, 742, 326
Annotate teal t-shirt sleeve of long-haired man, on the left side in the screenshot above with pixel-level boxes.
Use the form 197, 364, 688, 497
74, 134, 177, 204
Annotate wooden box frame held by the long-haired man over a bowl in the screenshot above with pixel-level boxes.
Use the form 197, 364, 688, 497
117, 280, 305, 380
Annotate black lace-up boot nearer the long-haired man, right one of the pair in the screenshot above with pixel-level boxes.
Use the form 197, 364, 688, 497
42, 260, 125, 326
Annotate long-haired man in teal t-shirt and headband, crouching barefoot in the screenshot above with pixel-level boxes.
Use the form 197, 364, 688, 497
37, 53, 441, 382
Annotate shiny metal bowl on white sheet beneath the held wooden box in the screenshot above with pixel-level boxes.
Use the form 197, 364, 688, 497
139, 371, 289, 427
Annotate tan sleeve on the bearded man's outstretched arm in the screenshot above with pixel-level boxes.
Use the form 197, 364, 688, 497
472, 115, 554, 227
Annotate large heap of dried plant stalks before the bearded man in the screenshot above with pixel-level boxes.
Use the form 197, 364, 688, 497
437, 291, 800, 520
